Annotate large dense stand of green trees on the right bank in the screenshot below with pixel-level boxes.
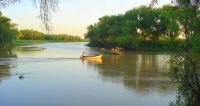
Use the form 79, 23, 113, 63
87, 5, 200, 50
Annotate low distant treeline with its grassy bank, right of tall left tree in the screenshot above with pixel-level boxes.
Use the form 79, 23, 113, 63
14, 30, 87, 46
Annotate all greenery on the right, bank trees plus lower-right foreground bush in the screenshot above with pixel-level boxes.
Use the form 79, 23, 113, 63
87, 3, 200, 106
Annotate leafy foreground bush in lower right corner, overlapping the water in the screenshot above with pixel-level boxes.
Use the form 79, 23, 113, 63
171, 54, 200, 106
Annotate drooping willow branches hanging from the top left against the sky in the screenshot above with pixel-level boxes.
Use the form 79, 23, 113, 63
0, 0, 59, 32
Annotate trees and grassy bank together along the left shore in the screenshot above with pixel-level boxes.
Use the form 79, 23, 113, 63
0, 12, 87, 47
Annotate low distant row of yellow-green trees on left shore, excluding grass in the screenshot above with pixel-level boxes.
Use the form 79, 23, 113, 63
18, 30, 81, 41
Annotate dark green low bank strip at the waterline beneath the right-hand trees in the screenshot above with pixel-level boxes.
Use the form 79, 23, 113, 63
87, 40, 186, 53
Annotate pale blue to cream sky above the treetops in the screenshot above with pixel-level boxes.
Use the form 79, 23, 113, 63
2, 0, 170, 37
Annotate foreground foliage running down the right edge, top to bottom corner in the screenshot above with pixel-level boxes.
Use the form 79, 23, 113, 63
171, 6, 200, 106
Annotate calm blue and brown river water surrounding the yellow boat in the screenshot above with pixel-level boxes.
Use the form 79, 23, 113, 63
0, 43, 175, 106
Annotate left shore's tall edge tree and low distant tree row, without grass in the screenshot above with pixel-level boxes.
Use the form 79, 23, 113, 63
0, 12, 83, 45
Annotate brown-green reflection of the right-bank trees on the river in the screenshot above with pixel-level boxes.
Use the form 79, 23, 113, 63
86, 54, 174, 93
